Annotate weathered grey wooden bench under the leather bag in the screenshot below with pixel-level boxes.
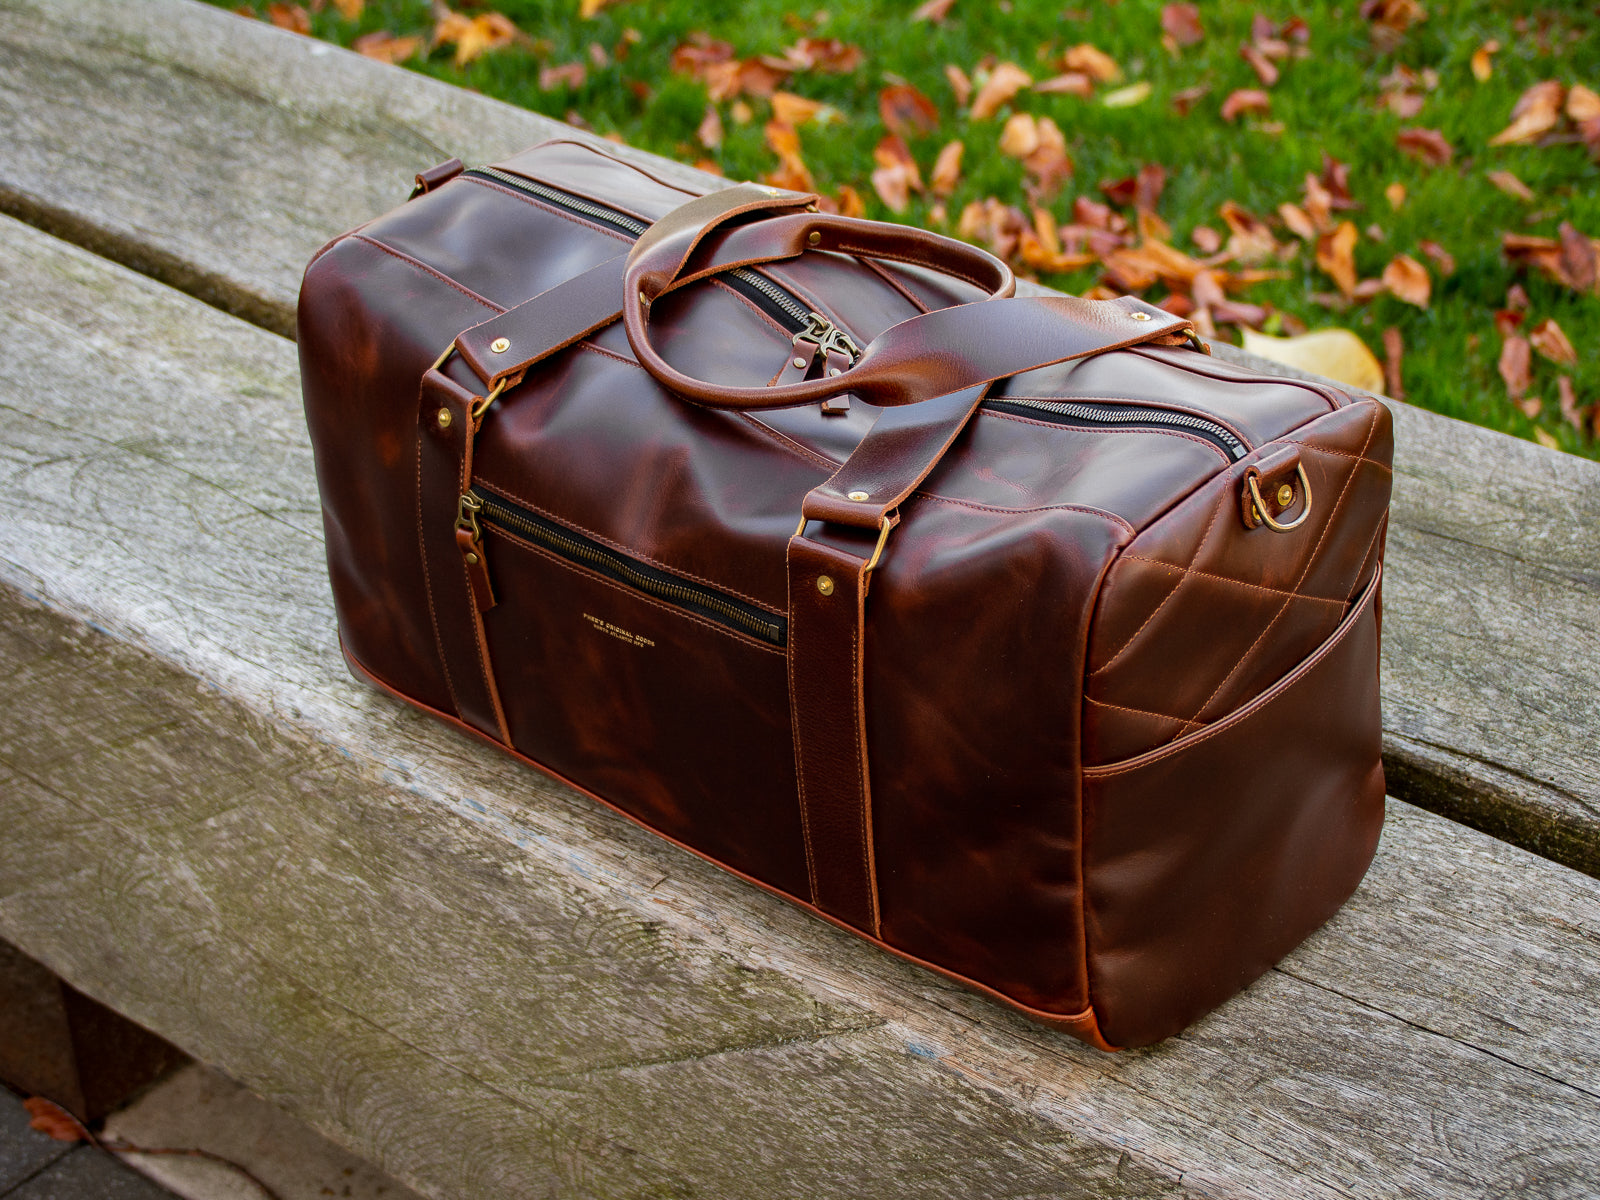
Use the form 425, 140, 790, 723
0, 0, 1600, 1198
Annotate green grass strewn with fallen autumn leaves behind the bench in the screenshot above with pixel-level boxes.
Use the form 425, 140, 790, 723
232, 0, 1600, 458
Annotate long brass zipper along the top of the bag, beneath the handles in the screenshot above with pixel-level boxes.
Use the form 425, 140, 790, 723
464, 166, 1250, 461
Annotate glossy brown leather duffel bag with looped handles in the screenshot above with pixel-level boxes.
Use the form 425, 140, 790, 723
299, 141, 1390, 1048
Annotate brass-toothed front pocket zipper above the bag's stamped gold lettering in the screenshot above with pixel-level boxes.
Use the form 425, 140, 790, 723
461, 488, 789, 646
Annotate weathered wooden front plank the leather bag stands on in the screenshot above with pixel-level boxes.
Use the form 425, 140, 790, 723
0, 221, 1600, 1198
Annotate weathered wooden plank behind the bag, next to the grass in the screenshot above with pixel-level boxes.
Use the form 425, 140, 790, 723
0, 0, 1600, 875
